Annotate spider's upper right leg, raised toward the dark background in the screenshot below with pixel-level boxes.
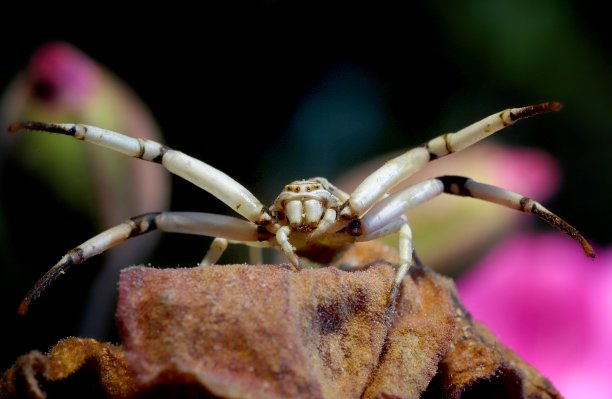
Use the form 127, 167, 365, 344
340, 102, 561, 218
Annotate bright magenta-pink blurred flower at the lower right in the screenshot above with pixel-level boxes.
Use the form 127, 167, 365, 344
457, 232, 612, 398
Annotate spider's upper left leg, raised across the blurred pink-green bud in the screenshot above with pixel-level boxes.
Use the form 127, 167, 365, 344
9, 122, 271, 224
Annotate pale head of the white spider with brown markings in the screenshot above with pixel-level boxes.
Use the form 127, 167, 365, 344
270, 177, 346, 231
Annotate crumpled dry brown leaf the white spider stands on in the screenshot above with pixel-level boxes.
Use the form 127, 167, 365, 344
0, 243, 560, 399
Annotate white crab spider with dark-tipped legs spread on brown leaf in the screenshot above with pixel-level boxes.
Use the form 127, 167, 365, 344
9, 102, 595, 314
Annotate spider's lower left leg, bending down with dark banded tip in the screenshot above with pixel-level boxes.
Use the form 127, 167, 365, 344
18, 212, 268, 315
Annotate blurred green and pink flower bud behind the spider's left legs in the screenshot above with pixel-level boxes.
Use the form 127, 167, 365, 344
0, 42, 170, 337
